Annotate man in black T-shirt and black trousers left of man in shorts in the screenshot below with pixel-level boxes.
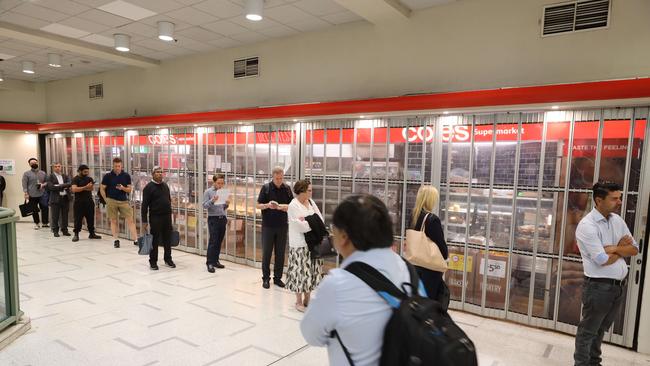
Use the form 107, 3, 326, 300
70, 164, 102, 242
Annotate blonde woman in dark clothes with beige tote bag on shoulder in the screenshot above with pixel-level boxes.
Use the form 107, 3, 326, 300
404, 185, 449, 300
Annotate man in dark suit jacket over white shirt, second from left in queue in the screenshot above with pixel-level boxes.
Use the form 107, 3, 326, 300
46, 163, 72, 238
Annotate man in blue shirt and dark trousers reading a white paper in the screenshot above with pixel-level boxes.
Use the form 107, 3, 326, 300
203, 174, 230, 273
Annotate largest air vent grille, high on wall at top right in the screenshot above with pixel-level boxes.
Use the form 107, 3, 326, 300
542, 0, 611, 36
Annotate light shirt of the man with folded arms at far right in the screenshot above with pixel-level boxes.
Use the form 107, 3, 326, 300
576, 208, 639, 280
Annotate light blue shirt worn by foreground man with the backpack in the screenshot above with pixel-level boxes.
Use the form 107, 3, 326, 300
300, 248, 410, 366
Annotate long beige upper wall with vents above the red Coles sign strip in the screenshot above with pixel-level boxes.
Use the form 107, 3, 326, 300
47, 0, 650, 121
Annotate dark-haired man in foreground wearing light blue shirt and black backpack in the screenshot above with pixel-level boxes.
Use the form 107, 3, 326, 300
300, 195, 478, 366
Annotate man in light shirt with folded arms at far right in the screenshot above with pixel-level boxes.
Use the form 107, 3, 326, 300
573, 182, 639, 366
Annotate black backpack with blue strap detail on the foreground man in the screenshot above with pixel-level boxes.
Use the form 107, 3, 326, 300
332, 260, 478, 366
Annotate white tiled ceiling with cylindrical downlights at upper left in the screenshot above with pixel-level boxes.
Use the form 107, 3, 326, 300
0, 0, 454, 82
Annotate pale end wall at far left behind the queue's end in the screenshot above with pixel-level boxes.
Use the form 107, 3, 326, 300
0, 132, 38, 220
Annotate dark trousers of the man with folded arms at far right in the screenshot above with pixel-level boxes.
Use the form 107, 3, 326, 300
573, 279, 625, 366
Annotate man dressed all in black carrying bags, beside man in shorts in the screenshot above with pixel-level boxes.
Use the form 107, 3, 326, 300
141, 166, 176, 271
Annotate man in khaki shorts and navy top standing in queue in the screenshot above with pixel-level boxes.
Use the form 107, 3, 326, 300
100, 158, 138, 248
